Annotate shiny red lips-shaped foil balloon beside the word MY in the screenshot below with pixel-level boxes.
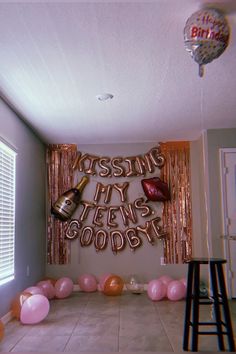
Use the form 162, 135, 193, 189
141, 177, 170, 202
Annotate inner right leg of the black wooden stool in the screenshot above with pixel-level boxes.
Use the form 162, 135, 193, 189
210, 262, 225, 351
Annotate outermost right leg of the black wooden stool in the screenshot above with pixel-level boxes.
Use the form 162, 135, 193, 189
217, 264, 236, 352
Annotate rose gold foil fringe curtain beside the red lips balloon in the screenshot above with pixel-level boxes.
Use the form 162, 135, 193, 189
160, 141, 192, 263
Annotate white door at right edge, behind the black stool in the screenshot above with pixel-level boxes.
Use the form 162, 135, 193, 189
220, 148, 236, 298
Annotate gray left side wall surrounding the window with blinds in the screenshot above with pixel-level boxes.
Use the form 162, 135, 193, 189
0, 101, 46, 317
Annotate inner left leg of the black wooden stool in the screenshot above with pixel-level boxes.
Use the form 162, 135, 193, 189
192, 263, 200, 352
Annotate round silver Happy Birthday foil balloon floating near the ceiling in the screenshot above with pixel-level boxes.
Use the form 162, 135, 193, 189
184, 9, 230, 77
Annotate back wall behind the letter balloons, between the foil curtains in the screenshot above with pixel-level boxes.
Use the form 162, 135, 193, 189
46, 142, 186, 282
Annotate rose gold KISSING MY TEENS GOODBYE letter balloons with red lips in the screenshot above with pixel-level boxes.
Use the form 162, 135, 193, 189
59, 146, 170, 254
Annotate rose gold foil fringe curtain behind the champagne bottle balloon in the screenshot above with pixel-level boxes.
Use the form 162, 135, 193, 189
47, 144, 77, 264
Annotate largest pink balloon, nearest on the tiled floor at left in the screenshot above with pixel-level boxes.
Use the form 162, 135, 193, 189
20, 294, 50, 324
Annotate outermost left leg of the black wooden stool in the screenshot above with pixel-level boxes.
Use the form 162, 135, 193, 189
183, 262, 194, 351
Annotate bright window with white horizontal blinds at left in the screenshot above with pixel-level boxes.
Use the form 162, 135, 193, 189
0, 141, 16, 285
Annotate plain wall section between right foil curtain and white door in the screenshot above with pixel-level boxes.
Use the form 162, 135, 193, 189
191, 128, 236, 280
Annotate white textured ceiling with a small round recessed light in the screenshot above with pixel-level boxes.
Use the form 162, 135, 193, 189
0, 0, 236, 144
